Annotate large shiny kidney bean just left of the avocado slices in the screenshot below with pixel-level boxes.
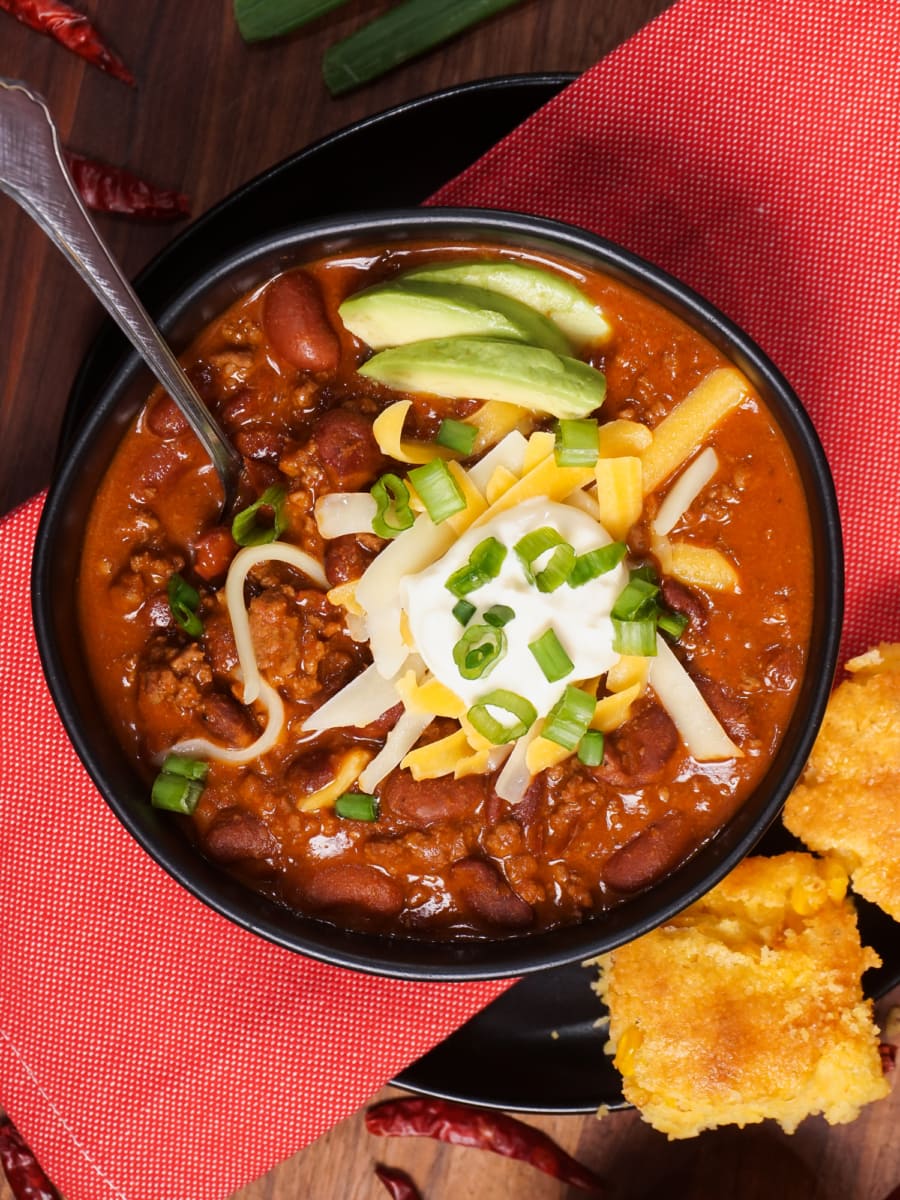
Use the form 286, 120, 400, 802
263, 271, 341, 371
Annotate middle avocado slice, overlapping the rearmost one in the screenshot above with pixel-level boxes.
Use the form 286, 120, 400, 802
338, 278, 571, 354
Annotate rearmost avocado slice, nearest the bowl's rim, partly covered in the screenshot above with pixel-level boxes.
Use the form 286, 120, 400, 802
402, 258, 612, 348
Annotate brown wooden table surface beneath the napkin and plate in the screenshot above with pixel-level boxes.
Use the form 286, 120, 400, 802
0, 0, 900, 1200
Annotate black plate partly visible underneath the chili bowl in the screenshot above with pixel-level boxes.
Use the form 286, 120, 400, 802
60, 74, 900, 1114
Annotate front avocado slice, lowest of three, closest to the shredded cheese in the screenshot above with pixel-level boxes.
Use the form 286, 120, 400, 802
359, 337, 606, 419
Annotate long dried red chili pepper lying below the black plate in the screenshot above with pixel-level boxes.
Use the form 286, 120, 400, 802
366, 1097, 605, 1194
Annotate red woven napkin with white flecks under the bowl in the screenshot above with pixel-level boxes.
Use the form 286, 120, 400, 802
0, 0, 900, 1200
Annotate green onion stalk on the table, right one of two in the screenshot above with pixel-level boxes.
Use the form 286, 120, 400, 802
322, 0, 518, 96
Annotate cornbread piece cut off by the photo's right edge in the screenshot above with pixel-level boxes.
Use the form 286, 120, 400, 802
784, 643, 900, 920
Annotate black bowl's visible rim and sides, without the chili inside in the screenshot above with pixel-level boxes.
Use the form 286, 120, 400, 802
32, 209, 842, 979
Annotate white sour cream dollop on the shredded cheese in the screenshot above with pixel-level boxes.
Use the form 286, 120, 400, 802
401, 498, 628, 716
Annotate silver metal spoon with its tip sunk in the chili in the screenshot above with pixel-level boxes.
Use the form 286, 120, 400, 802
0, 78, 241, 511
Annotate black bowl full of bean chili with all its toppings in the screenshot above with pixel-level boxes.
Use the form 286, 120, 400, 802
34, 209, 842, 979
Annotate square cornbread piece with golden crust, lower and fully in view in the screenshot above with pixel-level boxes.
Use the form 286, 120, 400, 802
596, 853, 888, 1138
